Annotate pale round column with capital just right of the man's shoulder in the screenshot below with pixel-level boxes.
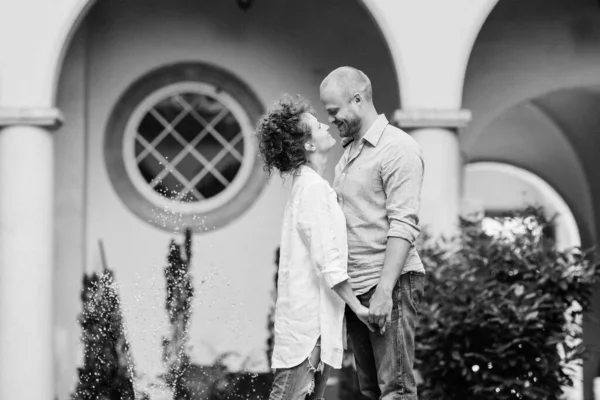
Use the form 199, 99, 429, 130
394, 110, 471, 237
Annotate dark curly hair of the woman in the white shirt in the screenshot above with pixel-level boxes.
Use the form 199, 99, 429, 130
256, 94, 314, 175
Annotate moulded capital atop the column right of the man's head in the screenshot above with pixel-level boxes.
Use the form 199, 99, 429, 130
392, 109, 471, 128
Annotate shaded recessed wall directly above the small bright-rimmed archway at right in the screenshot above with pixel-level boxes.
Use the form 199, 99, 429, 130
461, 87, 600, 246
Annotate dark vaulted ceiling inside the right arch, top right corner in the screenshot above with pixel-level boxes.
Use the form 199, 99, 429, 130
463, 0, 600, 137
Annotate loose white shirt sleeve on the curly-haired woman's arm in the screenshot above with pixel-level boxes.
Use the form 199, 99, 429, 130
298, 182, 350, 288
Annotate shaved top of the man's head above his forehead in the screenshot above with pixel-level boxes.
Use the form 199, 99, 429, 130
320, 67, 373, 102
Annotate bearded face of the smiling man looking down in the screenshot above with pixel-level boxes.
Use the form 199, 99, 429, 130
321, 88, 362, 138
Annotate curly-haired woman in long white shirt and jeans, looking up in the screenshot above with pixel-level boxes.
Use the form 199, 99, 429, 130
256, 95, 373, 400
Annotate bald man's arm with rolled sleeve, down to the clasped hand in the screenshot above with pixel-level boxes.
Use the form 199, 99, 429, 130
369, 139, 424, 333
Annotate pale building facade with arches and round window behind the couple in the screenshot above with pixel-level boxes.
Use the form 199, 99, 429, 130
0, 0, 600, 400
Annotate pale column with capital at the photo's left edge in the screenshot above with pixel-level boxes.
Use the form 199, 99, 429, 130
0, 108, 60, 400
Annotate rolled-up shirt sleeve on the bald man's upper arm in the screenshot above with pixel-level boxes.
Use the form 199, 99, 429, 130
381, 143, 424, 244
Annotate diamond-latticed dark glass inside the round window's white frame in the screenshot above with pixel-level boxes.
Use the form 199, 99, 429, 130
135, 92, 244, 203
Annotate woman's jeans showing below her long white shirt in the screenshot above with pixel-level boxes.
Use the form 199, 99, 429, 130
269, 342, 331, 400
